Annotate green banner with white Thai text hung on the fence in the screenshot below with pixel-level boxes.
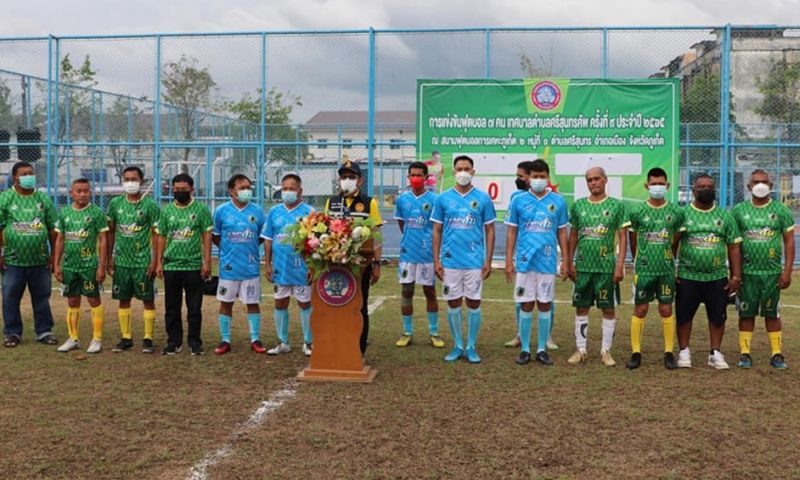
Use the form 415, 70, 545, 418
417, 78, 680, 210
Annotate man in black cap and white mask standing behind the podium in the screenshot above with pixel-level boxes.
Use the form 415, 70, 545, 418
325, 157, 383, 355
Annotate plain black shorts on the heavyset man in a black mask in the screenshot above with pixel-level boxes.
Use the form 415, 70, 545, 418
675, 278, 728, 326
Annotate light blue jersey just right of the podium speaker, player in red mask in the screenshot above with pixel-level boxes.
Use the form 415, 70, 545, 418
394, 190, 438, 263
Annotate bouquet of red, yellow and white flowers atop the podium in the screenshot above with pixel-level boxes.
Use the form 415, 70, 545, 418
284, 212, 380, 280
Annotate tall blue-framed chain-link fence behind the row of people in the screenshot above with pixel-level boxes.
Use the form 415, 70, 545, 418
0, 26, 800, 252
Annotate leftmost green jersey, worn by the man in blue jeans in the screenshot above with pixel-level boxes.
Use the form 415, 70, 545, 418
0, 187, 56, 267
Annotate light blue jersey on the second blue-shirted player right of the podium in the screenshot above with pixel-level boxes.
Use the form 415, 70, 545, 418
431, 187, 497, 270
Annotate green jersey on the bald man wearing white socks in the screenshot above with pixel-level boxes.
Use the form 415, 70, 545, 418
569, 197, 629, 273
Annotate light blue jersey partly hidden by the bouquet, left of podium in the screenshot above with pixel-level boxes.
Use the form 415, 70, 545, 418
261, 203, 314, 285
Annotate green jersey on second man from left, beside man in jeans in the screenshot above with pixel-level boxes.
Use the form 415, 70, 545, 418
55, 203, 108, 272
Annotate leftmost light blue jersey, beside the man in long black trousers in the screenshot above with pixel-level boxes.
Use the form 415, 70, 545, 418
211, 202, 266, 280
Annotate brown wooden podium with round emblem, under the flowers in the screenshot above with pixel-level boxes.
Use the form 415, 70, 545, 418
297, 241, 378, 383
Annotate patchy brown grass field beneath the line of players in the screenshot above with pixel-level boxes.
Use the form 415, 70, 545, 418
0, 268, 800, 479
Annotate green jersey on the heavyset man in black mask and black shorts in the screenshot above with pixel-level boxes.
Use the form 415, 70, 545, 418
678, 205, 742, 282
